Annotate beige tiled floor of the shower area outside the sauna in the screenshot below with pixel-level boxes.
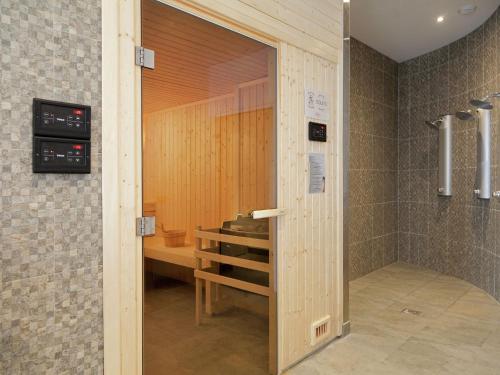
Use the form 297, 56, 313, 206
287, 263, 500, 375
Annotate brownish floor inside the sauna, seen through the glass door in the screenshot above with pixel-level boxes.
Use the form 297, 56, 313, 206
144, 280, 268, 375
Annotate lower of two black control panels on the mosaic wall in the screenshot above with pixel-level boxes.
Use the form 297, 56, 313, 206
33, 136, 90, 173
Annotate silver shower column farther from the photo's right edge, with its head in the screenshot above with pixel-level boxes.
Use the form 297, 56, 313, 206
425, 115, 453, 197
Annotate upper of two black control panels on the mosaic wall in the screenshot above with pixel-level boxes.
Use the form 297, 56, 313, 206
33, 99, 91, 139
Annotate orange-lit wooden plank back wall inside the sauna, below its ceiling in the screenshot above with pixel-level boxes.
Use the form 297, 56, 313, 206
143, 80, 274, 242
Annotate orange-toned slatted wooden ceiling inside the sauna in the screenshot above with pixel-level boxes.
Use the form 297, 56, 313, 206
142, 0, 270, 113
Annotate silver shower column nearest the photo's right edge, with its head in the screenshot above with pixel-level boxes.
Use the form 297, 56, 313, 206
456, 106, 490, 199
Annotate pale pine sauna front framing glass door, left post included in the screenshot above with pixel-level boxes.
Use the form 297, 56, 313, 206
102, 0, 342, 374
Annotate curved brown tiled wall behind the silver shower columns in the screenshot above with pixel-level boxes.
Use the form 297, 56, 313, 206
398, 10, 500, 300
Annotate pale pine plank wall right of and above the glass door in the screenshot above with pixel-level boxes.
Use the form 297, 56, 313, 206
142, 0, 343, 370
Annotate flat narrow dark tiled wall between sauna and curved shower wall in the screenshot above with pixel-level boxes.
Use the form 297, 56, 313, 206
349, 38, 398, 280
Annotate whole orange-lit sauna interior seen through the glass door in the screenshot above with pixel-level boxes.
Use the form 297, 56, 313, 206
142, 0, 276, 375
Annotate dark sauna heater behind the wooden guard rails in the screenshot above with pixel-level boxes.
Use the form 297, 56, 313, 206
220, 215, 269, 286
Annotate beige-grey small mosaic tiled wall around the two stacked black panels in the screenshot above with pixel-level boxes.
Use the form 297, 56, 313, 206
0, 0, 103, 374
